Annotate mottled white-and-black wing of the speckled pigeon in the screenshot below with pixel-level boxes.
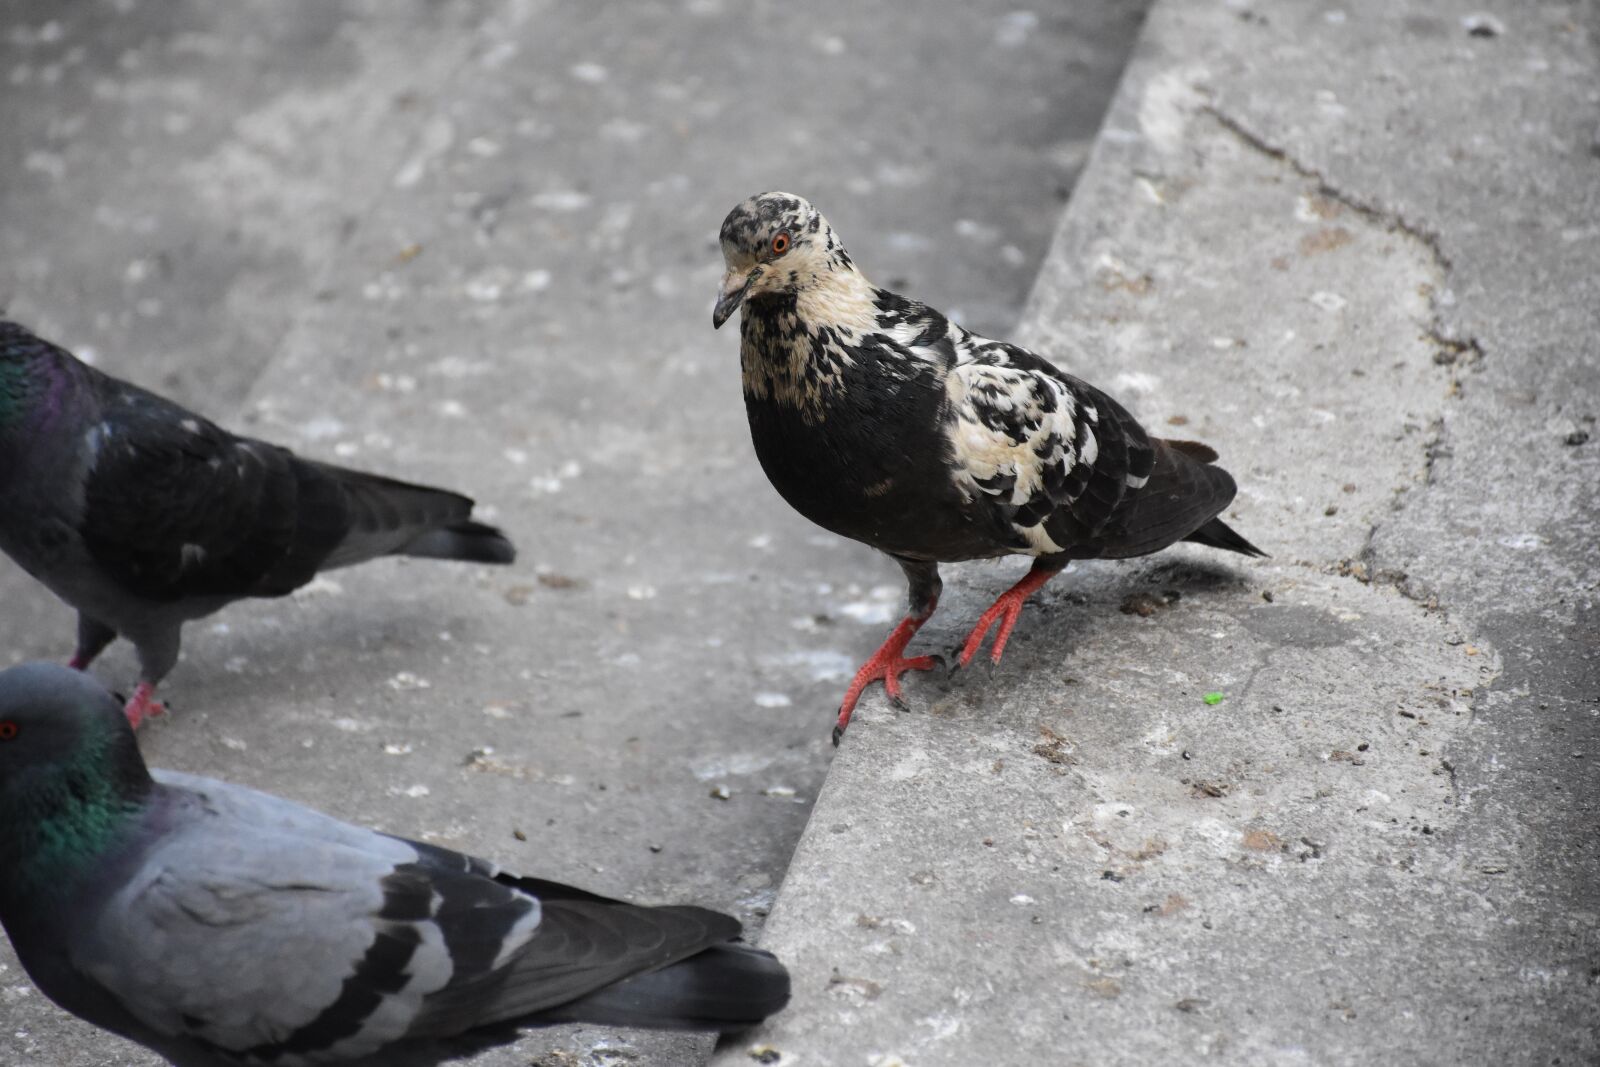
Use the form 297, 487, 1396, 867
946, 342, 1155, 555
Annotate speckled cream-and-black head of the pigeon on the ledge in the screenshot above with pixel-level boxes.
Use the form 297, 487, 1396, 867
710, 192, 851, 328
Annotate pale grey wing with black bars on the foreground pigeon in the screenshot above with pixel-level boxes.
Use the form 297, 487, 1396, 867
70, 773, 539, 1067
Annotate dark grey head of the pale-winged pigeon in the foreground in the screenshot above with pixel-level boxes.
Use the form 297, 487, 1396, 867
0, 662, 149, 805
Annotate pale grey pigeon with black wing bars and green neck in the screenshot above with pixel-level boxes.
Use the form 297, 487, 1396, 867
0, 664, 789, 1067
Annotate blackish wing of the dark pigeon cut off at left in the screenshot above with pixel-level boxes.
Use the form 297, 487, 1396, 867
80, 379, 350, 601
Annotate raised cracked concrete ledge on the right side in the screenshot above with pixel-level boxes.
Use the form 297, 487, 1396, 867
732, 0, 1600, 1067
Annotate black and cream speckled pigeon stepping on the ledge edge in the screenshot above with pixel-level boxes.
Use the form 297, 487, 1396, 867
712, 192, 1264, 742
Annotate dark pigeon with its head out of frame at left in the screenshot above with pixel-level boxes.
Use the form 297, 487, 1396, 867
0, 322, 515, 726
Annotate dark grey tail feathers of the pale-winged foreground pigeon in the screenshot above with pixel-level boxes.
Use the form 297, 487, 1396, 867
539, 944, 789, 1033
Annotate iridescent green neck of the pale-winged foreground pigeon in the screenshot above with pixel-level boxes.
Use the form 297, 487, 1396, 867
0, 728, 155, 913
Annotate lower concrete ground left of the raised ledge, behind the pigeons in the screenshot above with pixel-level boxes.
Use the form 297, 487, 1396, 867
0, 0, 1142, 1067
